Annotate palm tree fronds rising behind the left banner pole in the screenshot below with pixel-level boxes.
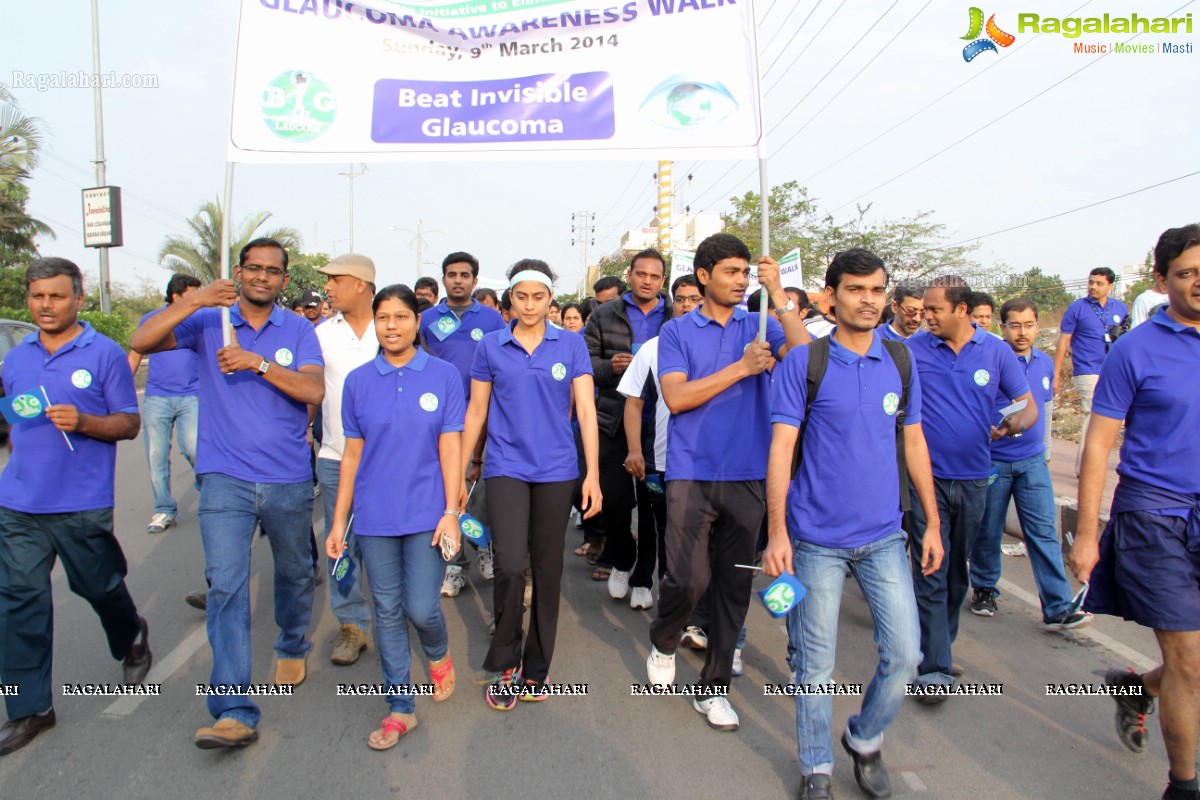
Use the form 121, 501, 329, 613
158, 200, 300, 283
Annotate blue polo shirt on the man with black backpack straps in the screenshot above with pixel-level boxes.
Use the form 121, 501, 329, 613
770, 336, 920, 548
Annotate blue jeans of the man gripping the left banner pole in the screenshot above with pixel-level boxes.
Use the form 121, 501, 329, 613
199, 473, 313, 728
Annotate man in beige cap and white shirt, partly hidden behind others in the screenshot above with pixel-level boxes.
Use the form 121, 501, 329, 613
317, 253, 379, 667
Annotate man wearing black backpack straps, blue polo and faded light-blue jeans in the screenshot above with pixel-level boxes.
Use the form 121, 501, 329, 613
763, 247, 942, 799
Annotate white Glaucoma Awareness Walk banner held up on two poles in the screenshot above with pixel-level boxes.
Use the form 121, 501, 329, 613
228, 0, 766, 163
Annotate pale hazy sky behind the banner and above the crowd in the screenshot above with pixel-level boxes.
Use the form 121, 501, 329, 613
0, 0, 1200, 299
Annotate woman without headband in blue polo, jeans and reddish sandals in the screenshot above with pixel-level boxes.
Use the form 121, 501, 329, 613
325, 284, 464, 750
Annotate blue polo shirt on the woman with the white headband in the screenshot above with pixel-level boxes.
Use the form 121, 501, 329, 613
470, 320, 592, 483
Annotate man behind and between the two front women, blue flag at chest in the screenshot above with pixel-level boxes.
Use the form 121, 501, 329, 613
415, 252, 504, 597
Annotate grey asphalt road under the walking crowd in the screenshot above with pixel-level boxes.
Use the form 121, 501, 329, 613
0, 441, 1166, 800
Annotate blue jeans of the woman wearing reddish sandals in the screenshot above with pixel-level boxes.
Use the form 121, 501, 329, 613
359, 530, 450, 714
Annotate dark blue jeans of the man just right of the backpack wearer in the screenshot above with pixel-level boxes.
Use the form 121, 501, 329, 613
905, 477, 988, 686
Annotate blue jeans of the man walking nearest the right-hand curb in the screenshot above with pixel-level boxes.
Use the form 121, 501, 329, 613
971, 453, 1070, 622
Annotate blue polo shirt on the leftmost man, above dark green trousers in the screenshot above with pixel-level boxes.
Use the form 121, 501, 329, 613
0, 321, 138, 513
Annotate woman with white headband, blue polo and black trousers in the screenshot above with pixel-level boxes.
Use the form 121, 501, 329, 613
462, 259, 600, 711
